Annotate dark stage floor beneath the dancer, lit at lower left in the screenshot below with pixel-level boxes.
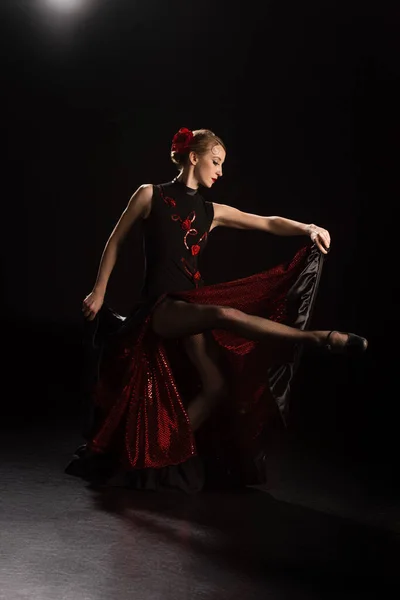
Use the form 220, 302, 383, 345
0, 406, 400, 600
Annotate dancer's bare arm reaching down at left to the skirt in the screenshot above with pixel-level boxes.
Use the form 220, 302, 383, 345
82, 184, 153, 321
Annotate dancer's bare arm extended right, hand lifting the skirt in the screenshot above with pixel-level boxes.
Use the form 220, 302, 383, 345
211, 202, 331, 254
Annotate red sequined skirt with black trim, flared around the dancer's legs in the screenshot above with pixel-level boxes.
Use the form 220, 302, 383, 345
66, 244, 323, 492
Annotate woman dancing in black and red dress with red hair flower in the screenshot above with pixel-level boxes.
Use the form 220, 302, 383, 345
67, 128, 367, 491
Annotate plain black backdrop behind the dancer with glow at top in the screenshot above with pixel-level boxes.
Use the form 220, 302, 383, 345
0, 0, 400, 479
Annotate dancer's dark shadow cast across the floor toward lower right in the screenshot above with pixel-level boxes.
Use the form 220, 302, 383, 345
88, 488, 399, 598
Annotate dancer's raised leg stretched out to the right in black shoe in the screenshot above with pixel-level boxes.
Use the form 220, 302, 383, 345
152, 298, 367, 352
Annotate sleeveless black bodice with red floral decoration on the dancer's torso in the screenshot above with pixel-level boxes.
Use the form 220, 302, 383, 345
142, 179, 214, 298
